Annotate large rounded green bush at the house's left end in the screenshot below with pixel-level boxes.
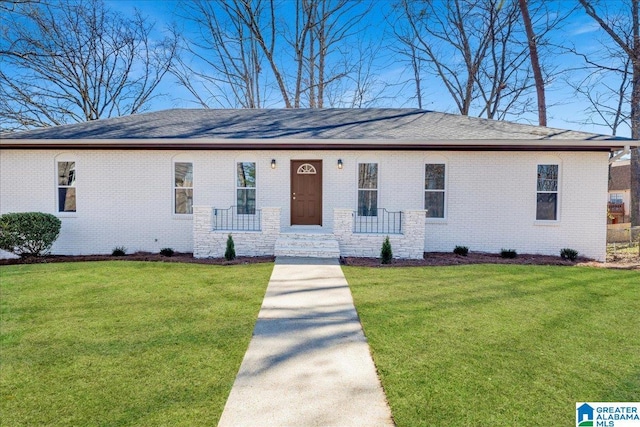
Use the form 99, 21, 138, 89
0, 212, 62, 257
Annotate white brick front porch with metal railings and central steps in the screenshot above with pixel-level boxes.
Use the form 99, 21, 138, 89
193, 206, 425, 259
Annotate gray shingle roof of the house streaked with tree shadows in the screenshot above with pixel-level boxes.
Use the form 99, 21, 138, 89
0, 109, 624, 141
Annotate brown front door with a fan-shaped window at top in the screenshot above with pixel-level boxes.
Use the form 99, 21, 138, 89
291, 160, 322, 225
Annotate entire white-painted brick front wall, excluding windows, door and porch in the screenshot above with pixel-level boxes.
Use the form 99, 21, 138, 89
0, 150, 607, 259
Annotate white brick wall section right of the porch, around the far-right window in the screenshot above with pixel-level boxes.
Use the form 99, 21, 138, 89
425, 152, 608, 260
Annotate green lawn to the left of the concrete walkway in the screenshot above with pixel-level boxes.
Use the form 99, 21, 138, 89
0, 261, 273, 426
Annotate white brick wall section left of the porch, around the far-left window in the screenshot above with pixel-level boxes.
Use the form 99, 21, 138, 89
0, 150, 193, 254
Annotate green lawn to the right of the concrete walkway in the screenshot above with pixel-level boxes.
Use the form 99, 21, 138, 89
343, 265, 640, 427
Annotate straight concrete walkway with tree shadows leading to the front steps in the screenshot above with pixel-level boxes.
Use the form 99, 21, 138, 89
218, 258, 394, 427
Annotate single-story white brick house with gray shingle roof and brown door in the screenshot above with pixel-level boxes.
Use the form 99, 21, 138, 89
0, 109, 638, 260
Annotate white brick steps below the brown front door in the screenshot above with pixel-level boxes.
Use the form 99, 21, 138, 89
275, 234, 340, 258
